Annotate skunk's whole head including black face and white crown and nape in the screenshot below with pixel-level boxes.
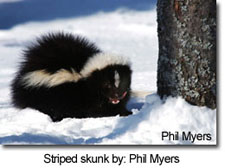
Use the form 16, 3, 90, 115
83, 52, 132, 104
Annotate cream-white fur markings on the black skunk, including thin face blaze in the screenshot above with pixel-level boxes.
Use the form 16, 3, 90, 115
22, 53, 130, 87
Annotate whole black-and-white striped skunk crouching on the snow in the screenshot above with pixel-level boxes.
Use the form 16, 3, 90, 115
11, 33, 132, 121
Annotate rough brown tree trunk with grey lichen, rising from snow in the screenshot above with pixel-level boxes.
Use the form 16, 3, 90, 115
157, 0, 216, 109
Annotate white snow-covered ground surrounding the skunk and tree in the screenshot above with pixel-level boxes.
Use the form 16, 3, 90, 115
0, 0, 216, 144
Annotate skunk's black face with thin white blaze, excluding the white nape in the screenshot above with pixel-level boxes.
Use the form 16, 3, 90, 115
98, 65, 131, 104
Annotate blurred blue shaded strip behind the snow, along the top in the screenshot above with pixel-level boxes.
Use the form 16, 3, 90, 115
0, 0, 156, 29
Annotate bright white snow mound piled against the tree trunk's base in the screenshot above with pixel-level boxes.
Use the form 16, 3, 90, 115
101, 94, 216, 144
